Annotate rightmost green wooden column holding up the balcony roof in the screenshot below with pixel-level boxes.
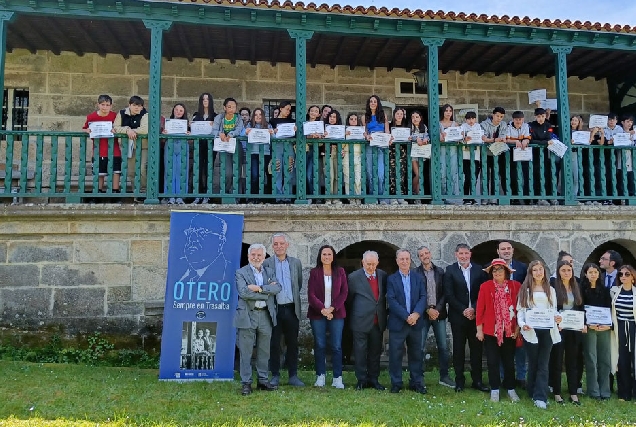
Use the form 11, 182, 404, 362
550, 46, 576, 205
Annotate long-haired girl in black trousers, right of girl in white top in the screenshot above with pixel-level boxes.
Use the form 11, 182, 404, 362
549, 261, 587, 406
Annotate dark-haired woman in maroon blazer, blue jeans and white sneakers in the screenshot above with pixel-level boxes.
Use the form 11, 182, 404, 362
307, 245, 349, 389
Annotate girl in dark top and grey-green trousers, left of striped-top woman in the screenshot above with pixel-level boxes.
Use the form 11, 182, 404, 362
581, 263, 612, 400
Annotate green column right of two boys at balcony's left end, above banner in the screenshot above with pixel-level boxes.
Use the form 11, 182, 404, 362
144, 19, 172, 205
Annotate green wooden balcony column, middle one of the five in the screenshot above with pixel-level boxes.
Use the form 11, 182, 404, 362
287, 30, 317, 204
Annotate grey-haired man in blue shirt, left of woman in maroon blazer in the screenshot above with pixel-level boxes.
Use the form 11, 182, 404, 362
263, 233, 305, 387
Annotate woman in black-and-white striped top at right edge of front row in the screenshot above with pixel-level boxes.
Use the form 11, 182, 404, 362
610, 265, 636, 402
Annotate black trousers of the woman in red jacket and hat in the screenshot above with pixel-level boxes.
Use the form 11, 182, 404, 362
484, 335, 517, 390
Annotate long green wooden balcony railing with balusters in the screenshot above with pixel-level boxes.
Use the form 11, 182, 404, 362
0, 131, 636, 205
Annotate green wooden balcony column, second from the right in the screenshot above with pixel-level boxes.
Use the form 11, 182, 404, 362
422, 37, 444, 205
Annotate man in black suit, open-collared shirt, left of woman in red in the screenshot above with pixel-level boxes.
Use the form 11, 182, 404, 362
443, 243, 490, 392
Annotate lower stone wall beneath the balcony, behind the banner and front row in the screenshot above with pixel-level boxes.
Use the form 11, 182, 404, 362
0, 205, 636, 335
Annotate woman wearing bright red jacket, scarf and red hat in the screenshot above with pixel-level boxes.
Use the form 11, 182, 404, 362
475, 258, 521, 402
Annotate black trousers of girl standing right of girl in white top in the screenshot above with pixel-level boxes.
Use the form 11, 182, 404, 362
549, 330, 582, 395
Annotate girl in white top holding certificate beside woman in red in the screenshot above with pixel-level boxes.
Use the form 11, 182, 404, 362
517, 261, 561, 409
